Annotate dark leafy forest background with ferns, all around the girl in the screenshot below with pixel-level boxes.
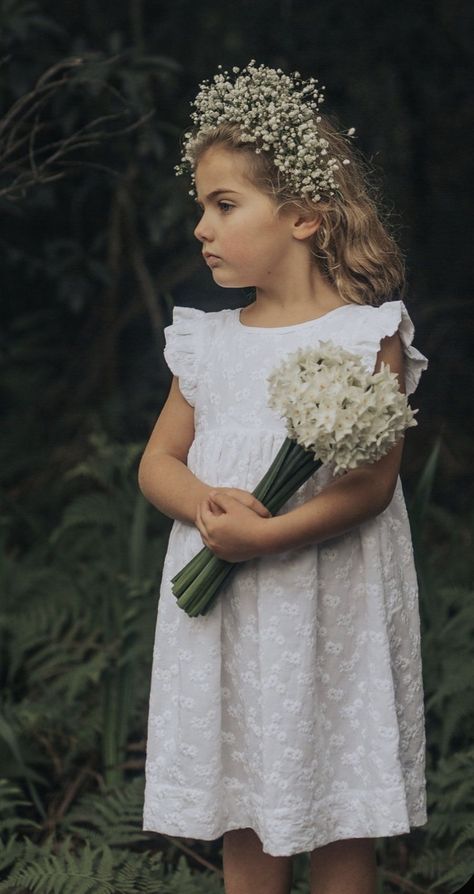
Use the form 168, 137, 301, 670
0, 0, 474, 894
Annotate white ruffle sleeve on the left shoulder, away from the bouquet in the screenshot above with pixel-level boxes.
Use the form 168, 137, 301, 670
163, 306, 206, 407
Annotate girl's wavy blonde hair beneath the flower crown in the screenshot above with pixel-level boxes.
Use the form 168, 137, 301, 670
189, 117, 405, 305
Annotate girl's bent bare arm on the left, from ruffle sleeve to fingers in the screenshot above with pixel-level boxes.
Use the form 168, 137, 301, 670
138, 376, 270, 524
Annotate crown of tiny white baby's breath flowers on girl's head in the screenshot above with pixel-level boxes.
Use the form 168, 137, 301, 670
175, 59, 355, 202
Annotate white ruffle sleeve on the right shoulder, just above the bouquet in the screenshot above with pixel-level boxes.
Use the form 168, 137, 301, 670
357, 301, 428, 394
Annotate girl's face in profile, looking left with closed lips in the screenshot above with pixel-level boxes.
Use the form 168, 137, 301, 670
194, 146, 301, 288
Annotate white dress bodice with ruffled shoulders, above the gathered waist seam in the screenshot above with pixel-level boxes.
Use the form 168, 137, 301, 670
165, 301, 427, 435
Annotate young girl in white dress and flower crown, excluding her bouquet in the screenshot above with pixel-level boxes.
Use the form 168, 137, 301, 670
139, 62, 426, 894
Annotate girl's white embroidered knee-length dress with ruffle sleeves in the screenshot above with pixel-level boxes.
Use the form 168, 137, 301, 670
144, 301, 427, 856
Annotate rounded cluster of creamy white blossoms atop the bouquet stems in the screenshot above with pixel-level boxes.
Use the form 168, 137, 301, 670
268, 341, 416, 474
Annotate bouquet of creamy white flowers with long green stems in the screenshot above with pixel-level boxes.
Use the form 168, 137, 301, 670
171, 341, 416, 617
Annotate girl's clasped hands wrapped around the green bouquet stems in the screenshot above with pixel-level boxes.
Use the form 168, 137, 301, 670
196, 488, 271, 562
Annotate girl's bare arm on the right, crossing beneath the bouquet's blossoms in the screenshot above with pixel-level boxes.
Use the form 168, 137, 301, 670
197, 334, 405, 561
